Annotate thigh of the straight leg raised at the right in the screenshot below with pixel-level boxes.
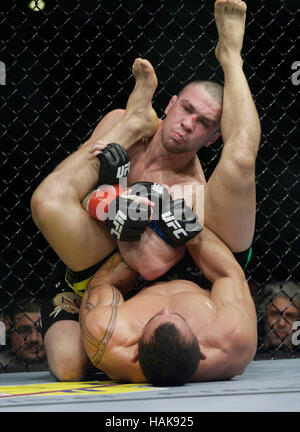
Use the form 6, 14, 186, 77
204, 154, 256, 252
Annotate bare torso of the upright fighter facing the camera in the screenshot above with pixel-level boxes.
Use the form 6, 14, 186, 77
118, 126, 206, 280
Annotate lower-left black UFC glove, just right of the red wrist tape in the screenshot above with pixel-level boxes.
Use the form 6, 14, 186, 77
106, 183, 151, 242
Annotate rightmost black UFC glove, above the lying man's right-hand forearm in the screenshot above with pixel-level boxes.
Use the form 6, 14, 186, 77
156, 198, 203, 246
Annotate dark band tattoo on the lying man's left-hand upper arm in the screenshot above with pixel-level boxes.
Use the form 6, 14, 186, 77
80, 285, 120, 368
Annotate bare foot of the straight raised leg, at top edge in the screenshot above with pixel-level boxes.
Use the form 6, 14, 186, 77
215, 0, 247, 63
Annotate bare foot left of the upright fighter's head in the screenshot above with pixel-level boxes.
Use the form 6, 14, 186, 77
124, 58, 159, 138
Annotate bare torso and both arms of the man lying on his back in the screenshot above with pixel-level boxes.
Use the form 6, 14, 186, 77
80, 228, 257, 382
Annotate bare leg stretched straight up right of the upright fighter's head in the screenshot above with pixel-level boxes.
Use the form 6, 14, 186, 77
205, 0, 261, 252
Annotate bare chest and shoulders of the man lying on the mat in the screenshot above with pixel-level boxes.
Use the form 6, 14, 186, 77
89, 280, 251, 382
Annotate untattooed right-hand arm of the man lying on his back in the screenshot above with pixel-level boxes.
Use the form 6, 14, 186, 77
188, 227, 257, 379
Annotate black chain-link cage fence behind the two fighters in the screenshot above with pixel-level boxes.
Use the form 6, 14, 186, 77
0, 0, 300, 372
